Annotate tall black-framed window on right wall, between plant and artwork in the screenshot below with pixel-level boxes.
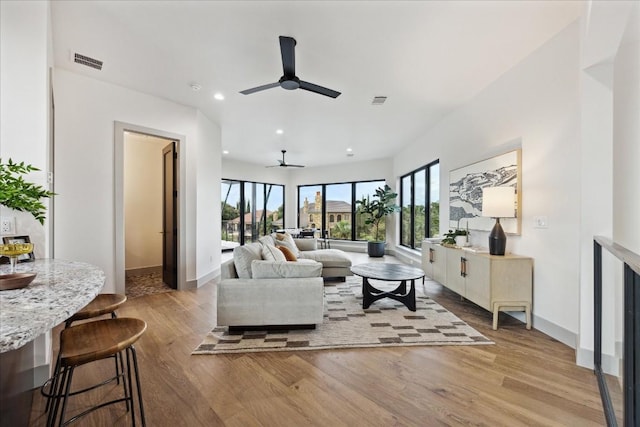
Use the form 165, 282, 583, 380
400, 160, 440, 250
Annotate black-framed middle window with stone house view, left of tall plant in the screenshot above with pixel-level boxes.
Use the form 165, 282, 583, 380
298, 180, 385, 240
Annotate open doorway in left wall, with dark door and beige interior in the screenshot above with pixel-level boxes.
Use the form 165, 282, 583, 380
115, 122, 185, 298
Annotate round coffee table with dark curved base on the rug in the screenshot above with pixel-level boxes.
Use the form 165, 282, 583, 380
351, 262, 424, 311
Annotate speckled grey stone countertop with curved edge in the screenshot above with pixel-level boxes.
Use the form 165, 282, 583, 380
0, 259, 105, 353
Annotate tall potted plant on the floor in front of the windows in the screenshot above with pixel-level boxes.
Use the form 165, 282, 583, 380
356, 184, 400, 257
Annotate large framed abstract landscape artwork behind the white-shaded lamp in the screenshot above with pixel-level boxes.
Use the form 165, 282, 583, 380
449, 149, 522, 234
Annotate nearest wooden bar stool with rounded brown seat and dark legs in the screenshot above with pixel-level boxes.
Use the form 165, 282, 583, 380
47, 317, 147, 427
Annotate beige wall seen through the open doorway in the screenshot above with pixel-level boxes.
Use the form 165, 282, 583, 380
124, 133, 162, 270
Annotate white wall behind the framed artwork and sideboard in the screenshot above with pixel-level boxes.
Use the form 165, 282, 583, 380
393, 24, 580, 345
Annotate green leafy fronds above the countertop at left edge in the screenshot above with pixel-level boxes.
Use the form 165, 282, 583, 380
0, 159, 55, 224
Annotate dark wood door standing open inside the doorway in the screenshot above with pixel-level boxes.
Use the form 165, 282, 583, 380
162, 141, 178, 289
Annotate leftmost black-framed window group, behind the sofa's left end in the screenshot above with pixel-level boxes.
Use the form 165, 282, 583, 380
221, 179, 284, 250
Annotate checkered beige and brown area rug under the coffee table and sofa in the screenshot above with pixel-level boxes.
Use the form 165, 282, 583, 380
192, 276, 493, 354
